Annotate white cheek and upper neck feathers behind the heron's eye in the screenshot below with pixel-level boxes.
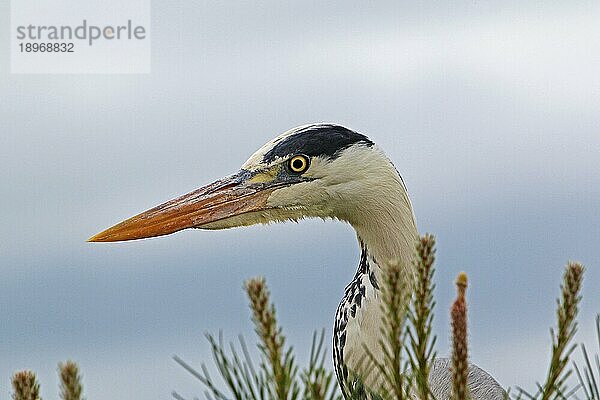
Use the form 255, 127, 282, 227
267, 145, 417, 260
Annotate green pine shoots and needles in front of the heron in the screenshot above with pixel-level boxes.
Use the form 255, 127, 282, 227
12, 235, 600, 400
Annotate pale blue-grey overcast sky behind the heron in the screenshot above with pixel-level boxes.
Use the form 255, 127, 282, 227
0, 0, 600, 400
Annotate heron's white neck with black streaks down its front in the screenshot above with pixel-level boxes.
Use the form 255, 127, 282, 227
333, 184, 417, 390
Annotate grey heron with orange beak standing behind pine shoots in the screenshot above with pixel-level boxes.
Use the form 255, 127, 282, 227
89, 124, 504, 399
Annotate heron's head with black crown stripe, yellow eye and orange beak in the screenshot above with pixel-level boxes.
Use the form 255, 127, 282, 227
89, 124, 404, 242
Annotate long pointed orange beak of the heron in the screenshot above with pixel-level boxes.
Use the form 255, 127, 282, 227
88, 170, 279, 242
